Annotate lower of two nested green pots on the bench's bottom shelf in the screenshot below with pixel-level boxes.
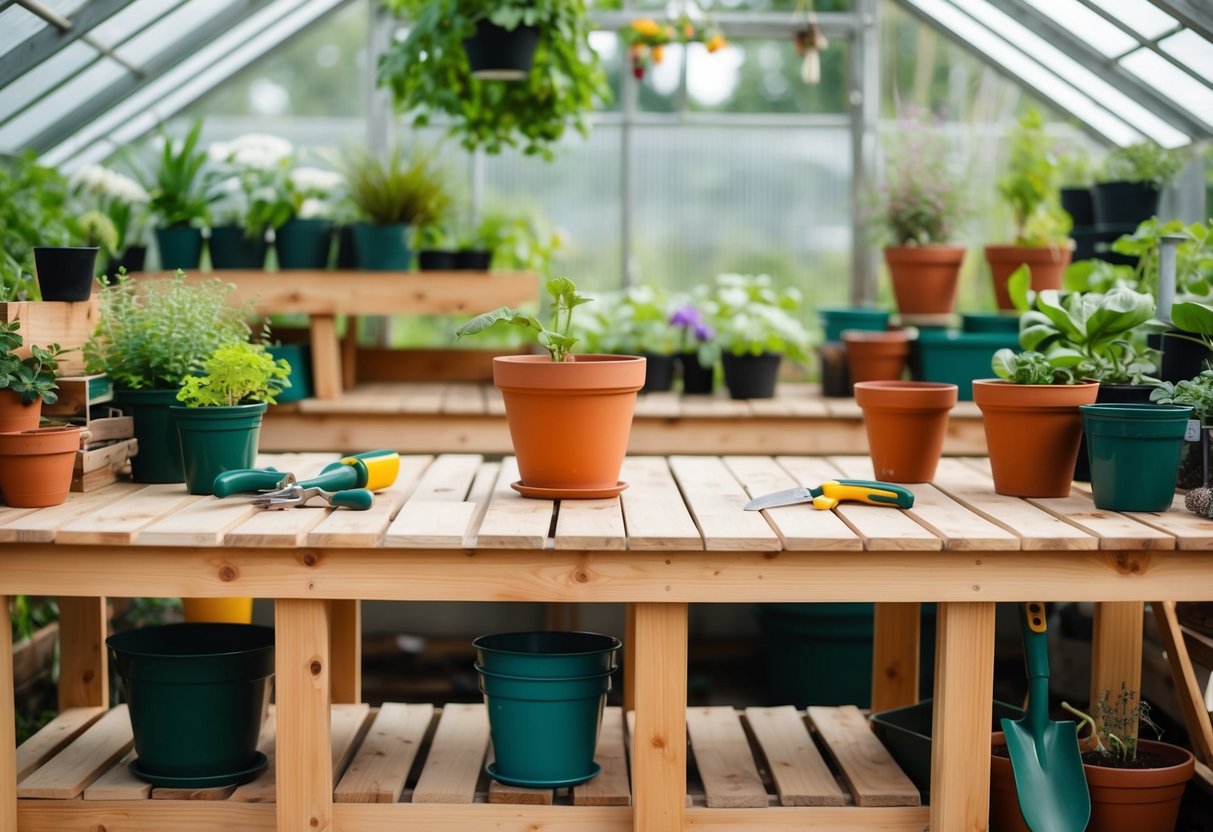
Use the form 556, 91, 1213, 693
477, 666, 614, 788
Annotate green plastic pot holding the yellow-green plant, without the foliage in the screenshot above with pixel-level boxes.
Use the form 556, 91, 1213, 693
169, 401, 266, 495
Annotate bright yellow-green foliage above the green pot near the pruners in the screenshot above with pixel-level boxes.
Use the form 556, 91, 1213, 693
177, 341, 291, 408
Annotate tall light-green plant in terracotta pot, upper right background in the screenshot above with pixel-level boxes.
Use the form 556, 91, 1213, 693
985, 110, 1074, 309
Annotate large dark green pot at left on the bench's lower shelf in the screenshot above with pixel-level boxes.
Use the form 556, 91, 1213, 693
106, 623, 274, 786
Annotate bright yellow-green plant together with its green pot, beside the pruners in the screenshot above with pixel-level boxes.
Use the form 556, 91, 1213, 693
169, 341, 291, 495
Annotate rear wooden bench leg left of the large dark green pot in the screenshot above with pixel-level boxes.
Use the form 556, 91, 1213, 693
59, 595, 109, 711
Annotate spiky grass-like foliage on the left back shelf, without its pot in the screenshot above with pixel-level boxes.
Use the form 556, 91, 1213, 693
340, 146, 451, 226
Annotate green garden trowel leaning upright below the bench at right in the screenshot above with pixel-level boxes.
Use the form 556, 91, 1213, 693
1002, 602, 1090, 832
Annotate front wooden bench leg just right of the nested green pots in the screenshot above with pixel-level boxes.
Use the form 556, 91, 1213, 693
631, 604, 687, 832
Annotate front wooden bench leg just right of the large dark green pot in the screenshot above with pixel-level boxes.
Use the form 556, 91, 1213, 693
274, 599, 332, 832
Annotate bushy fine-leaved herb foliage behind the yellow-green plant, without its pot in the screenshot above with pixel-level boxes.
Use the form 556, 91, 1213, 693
84, 269, 252, 389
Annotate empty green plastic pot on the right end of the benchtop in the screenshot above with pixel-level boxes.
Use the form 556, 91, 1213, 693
1078, 404, 1192, 512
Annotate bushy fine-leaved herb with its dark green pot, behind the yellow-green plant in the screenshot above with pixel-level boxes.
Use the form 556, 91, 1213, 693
85, 270, 251, 483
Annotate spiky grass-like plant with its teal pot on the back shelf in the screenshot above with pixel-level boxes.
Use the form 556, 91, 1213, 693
342, 147, 451, 272
